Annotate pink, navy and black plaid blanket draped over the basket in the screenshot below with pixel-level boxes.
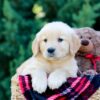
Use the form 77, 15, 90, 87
18, 74, 100, 100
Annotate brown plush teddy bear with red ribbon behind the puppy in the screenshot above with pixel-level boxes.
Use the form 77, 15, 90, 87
75, 27, 100, 73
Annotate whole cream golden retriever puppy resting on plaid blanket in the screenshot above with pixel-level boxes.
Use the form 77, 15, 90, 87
17, 22, 80, 93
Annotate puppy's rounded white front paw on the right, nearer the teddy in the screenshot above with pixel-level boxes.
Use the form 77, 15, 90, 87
48, 74, 66, 89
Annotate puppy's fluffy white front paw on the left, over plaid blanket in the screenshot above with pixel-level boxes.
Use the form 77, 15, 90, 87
32, 77, 47, 94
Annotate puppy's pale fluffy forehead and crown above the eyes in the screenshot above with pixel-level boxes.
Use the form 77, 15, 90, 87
40, 22, 74, 36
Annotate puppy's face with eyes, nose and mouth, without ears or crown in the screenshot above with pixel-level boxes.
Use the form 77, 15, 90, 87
40, 32, 69, 59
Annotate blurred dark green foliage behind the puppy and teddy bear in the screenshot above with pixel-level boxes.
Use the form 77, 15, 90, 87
0, 0, 100, 100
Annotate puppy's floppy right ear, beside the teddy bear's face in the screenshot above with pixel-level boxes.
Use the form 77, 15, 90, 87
70, 33, 81, 55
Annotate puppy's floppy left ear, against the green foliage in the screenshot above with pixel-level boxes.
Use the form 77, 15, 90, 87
32, 34, 40, 56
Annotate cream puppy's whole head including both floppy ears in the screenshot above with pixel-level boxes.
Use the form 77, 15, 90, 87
33, 22, 80, 60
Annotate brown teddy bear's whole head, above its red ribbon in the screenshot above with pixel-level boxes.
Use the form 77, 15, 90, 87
75, 27, 100, 55
